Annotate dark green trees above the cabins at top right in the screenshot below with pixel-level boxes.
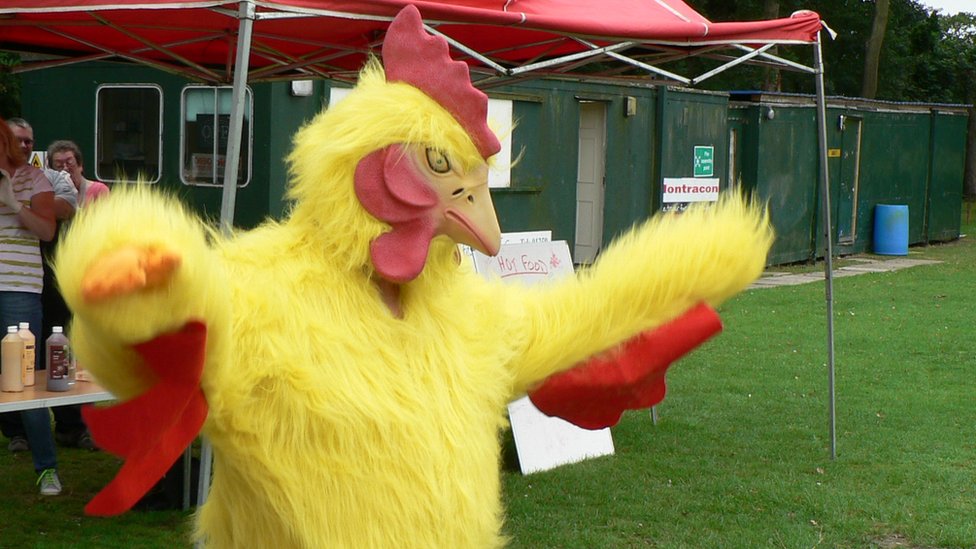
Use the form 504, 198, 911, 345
686, 0, 976, 104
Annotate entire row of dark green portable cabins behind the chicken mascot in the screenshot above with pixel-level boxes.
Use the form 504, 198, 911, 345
23, 63, 966, 264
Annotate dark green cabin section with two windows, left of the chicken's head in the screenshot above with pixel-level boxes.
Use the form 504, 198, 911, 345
22, 63, 323, 227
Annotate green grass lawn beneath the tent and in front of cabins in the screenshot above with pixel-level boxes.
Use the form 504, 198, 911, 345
0, 216, 976, 549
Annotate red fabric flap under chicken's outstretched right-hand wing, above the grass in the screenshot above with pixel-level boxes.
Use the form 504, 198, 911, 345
529, 304, 722, 429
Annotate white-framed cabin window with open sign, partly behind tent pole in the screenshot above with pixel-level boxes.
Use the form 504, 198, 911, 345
180, 86, 252, 187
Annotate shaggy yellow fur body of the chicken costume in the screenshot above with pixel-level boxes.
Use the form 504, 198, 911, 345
56, 63, 772, 549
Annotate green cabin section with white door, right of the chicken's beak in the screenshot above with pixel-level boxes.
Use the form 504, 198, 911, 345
489, 79, 657, 263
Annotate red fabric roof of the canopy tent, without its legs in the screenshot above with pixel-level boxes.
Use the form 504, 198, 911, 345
0, 0, 821, 84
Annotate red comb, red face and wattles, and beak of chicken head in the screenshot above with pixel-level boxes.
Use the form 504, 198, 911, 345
355, 2, 501, 283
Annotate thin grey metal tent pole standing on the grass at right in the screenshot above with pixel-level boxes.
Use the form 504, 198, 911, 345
813, 32, 837, 460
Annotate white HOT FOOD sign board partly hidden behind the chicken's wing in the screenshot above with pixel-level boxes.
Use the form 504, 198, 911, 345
473, 238, 613, 475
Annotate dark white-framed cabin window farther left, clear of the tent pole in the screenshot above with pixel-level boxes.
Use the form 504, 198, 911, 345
94, 84, 163, 183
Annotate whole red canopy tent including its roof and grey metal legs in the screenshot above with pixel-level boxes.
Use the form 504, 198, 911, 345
0, 0, 836, 476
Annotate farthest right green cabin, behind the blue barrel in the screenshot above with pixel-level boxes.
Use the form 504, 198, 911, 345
729, 92, 967, 264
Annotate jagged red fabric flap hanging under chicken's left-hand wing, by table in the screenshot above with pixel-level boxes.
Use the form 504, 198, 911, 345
82, 321, 207, 516
